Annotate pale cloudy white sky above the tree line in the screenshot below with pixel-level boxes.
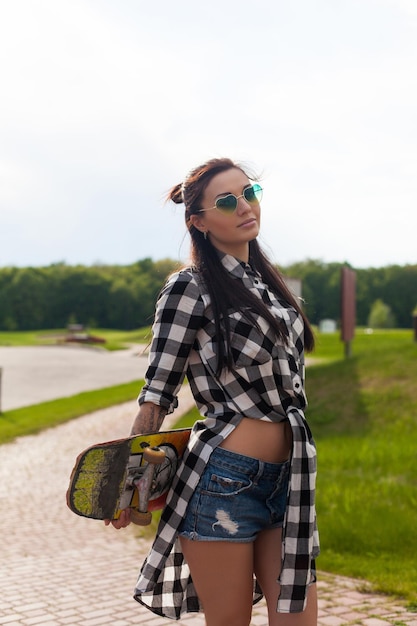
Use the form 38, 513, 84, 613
0, 0, 417, 268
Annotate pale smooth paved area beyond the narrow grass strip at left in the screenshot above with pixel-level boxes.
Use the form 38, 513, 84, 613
0, 344, 148, 411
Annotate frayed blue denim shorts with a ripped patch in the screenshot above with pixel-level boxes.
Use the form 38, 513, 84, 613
179, 448, 290, 543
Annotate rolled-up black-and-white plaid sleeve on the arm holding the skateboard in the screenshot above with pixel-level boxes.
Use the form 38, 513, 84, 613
139, 270, 204, 413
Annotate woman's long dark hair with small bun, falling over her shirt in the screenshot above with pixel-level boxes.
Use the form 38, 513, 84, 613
167, 158, 314, 373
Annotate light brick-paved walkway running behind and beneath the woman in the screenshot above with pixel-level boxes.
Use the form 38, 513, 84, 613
0, 392, 417, 626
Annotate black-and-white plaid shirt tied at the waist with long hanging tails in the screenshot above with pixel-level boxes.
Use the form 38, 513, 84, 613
135, 255, 319, 619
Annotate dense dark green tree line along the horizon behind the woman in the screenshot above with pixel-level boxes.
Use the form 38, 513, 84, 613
0, 258, 417, 330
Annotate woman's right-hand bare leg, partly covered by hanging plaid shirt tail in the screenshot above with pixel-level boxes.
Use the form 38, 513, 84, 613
254, 528, 317, 626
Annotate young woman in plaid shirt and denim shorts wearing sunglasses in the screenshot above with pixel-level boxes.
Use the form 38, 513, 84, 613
107, 159, 318, 626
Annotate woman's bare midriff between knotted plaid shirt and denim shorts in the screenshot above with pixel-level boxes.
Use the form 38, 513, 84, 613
220, 417, 292, 463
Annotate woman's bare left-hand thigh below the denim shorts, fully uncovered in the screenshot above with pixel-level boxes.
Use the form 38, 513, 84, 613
180, 537, 253, 626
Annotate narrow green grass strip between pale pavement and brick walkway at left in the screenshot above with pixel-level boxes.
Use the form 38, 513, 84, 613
0, 380, 143, 444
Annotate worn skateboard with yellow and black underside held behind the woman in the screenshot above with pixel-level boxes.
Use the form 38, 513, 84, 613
67, 428, 191, 526
